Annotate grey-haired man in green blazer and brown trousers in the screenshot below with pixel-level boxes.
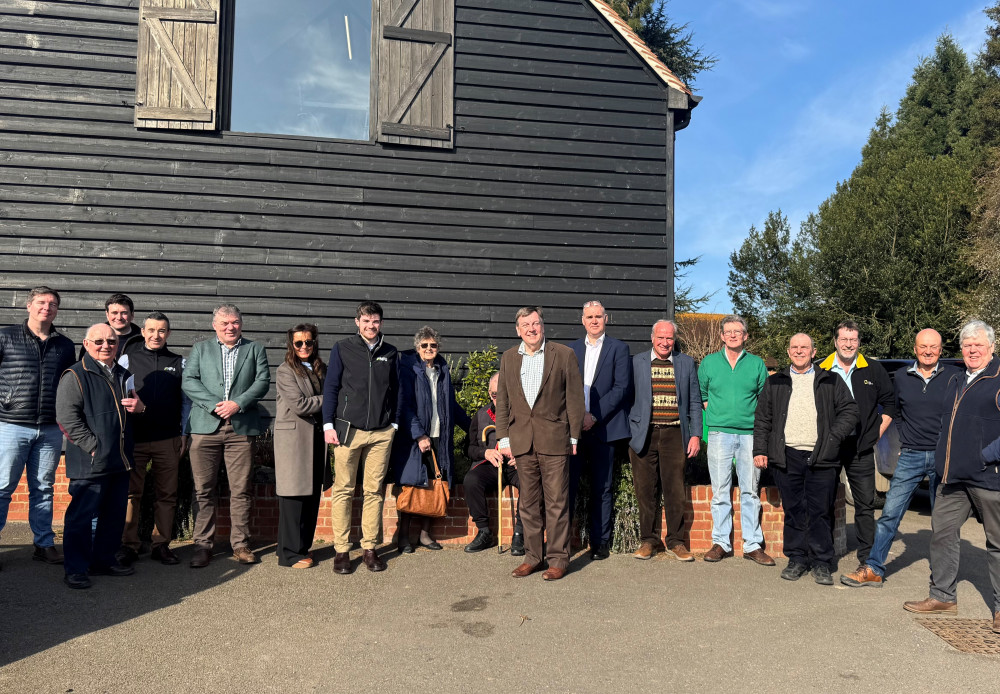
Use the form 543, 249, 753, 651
181, 304, 270, 569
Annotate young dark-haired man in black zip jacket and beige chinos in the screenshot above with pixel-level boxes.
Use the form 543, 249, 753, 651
323, 301, 399, 574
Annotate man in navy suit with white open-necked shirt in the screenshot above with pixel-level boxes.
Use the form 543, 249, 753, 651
569, 301, 632, 560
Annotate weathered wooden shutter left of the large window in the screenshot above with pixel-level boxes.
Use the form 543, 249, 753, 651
135, 0, 221, 130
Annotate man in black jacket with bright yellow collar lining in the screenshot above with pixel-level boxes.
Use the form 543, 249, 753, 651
820, 320, 896, 569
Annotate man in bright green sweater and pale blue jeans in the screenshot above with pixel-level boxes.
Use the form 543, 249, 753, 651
698, 315, 774, 566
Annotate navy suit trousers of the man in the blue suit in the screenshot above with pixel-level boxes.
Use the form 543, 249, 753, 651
569, 431, 615, 547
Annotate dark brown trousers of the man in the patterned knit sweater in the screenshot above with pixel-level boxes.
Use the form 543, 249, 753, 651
628, 426, 687, 549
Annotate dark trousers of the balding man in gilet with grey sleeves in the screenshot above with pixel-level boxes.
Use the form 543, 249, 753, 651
63, 471, 129, 574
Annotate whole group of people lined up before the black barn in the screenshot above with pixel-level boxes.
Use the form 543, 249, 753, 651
0, 287, 1000, 629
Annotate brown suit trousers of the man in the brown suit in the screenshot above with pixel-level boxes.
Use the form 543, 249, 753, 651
517, 449, 570, 569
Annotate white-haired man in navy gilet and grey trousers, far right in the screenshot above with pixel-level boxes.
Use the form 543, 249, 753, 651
903, 320, 1000, 633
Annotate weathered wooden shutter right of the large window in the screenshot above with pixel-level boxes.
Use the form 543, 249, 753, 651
377, 0, 455, 147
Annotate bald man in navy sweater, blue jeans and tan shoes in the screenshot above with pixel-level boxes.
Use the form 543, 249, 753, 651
840, 328, 960, 588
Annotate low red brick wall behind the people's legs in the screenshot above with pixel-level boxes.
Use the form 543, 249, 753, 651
7, 462, 847, 556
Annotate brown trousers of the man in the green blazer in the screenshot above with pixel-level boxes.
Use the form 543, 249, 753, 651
191, 422, 253, 549
